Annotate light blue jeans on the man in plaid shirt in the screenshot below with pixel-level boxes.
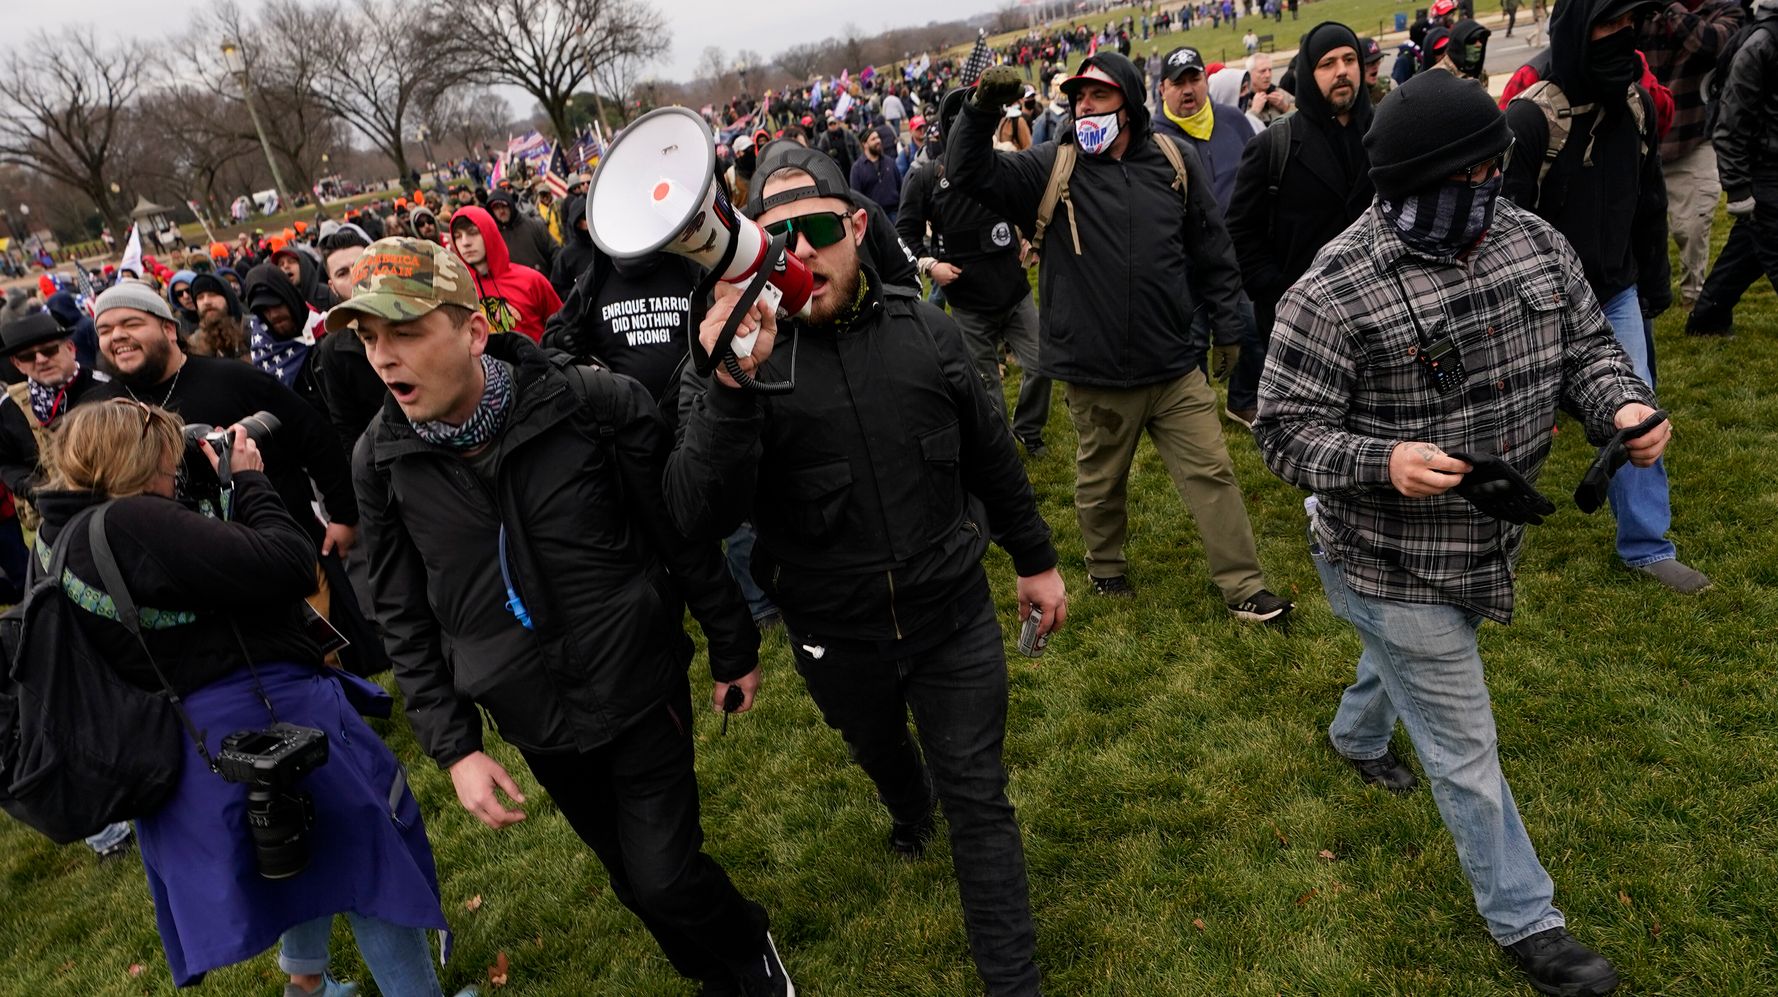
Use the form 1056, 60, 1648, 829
1309, 540, 1565, 945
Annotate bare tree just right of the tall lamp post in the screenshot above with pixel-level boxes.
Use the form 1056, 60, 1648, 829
315, 0, 464, 176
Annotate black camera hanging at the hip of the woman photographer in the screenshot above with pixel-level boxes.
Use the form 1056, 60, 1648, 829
215, 723, 327, 880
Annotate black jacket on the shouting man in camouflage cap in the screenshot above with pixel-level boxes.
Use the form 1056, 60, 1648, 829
352, 336, 759, 768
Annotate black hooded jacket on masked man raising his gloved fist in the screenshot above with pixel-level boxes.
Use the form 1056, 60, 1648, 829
944, 53, 1243, 387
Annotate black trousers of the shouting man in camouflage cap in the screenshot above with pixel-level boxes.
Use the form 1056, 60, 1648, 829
525, 671, 766, 985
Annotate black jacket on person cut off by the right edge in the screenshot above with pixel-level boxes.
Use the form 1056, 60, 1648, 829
1710, 14, 1778, 201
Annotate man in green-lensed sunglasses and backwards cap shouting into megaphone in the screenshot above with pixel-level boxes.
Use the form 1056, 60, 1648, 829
667, 142, 1067, 995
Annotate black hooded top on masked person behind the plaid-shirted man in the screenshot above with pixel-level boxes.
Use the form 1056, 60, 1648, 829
1502, 0, 1673, 313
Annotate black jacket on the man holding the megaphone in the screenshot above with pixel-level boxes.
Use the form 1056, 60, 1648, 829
667, 270, 1056, 643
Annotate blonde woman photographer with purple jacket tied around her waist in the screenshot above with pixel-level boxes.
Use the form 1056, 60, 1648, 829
39, 398, 468, 997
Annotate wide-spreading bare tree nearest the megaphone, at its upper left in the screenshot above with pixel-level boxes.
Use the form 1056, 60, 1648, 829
427, 0, 669, 137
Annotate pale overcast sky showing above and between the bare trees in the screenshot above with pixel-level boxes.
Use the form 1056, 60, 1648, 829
4, 0, 1003, 89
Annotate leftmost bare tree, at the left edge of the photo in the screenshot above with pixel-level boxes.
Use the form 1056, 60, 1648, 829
0, 28, 142, 238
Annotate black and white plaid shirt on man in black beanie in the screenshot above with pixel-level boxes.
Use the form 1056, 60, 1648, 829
1253, 199, 1654, 622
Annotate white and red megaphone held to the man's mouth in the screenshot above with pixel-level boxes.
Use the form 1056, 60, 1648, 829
587, 107, 814, 316
